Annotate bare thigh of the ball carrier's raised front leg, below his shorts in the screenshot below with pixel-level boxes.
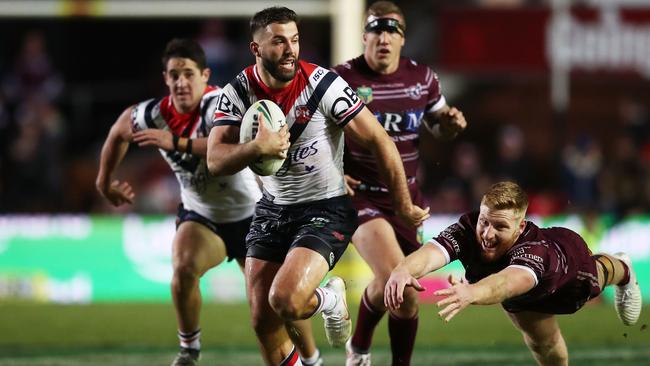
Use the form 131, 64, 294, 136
273, 247, 329, 301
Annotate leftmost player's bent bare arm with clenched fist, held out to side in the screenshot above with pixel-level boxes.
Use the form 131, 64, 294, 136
95, 107, 135, 206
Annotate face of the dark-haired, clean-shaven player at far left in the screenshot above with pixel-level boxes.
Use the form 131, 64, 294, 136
163, 57, 210, 113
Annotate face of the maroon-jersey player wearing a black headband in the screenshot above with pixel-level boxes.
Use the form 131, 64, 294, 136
363, 14, 404, 72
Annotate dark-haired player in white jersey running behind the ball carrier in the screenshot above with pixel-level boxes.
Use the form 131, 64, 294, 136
96, 39, 322, 366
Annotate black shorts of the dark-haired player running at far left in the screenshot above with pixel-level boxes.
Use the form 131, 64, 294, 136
176, 203, 253, 262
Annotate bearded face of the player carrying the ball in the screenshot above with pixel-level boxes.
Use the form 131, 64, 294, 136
251, 22, 300, 82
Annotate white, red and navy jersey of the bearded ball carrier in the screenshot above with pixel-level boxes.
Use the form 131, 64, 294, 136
214, 61, 364, 205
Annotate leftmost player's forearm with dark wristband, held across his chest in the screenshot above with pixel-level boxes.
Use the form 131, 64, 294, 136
133, 128, 208, 156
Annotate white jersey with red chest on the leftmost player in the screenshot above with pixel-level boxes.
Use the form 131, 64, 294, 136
132, 88, 261, 223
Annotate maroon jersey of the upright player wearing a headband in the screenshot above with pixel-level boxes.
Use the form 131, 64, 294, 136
334, 55, 445, 189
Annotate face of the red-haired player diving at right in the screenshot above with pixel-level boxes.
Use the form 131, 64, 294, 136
476, 205, 526, 262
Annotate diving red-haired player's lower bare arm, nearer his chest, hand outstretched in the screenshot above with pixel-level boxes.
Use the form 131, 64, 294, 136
434, 266, 537, 321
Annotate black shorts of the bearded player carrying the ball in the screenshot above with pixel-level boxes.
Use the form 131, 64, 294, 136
246, 195, 358, 270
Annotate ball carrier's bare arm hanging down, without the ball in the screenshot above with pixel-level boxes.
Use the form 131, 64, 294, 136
344, 107, 429, 226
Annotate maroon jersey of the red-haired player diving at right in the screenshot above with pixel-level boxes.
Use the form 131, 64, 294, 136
432, 212, 600, 314
